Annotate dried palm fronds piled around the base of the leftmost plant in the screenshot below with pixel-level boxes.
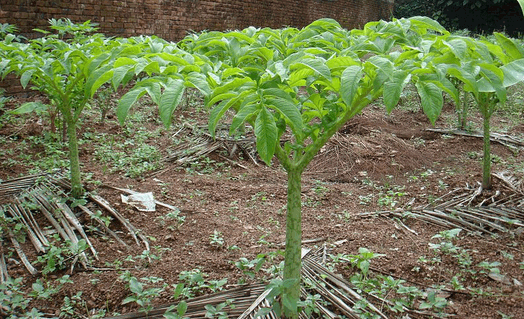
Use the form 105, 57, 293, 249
0, 172, 149, 280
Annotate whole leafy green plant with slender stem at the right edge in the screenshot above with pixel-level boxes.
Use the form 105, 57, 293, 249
426, 33, 524, 189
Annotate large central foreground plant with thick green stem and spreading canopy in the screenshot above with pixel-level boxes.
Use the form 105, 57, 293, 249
114, 17, 456, 318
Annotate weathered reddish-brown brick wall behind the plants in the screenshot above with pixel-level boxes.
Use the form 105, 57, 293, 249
0, 0, 394, 94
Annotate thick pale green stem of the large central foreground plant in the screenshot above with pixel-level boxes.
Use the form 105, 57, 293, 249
283, 169, 302, 318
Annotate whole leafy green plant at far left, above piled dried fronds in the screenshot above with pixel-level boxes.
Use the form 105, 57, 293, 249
0, 19, 162, 198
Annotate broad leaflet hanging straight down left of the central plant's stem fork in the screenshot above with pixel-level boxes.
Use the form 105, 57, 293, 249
255, 108, 278, 165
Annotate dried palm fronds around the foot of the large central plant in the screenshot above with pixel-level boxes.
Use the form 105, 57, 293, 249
106, 248, 419, 319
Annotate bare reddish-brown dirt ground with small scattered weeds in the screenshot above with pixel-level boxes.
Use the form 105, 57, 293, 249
0, 95, 524, 318
